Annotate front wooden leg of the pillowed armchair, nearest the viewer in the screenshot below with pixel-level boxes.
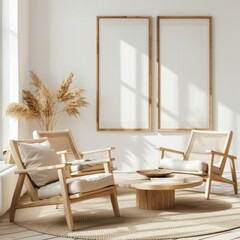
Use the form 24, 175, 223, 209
58, 169, 74, 231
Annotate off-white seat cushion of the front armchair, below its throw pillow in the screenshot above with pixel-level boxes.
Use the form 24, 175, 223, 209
38, 173, 114, 199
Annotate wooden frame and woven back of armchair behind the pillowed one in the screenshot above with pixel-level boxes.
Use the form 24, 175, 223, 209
33, 129, 115, 176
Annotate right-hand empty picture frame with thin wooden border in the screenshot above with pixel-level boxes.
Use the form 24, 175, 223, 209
156, 16, 212, 130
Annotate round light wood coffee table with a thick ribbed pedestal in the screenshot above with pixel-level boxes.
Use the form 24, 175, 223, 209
114, 173, 203, 210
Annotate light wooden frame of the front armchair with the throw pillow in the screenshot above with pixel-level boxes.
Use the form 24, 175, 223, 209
10, 138, 120, 230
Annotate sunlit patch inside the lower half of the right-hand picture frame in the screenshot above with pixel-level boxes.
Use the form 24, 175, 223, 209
160, 65, 209, 128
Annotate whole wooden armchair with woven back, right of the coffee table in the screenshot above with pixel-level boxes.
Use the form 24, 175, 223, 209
157, 130, 238, 199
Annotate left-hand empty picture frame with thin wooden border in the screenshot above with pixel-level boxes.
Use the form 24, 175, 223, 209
96, 16, 152, 131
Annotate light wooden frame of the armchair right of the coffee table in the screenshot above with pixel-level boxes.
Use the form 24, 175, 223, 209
157, 130, 238, 199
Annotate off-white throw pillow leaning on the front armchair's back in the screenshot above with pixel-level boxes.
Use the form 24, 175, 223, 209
18, 141, 61, 187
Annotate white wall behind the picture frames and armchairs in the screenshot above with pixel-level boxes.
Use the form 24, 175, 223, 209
30, 0, 240, 170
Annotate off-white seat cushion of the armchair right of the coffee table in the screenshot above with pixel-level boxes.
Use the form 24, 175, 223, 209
159, 158, 219, 173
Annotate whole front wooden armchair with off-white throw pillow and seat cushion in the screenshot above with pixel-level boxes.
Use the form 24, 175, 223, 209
10, 138, 120, 230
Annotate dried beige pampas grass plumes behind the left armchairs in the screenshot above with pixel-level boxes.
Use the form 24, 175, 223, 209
6, 72, 88, 131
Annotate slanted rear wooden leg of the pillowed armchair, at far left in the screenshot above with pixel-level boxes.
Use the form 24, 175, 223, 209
9, 173, 26, 222
